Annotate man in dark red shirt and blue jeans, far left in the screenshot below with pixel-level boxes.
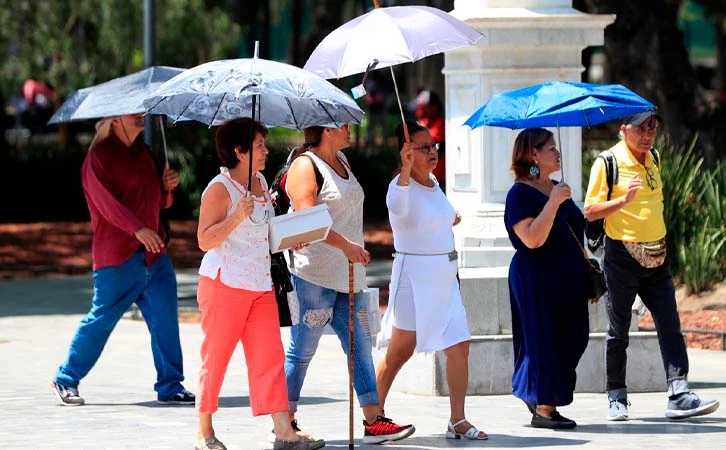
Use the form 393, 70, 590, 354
51, 114, 195, 406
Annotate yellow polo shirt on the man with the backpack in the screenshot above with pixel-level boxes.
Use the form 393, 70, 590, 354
585, 140, 666, 242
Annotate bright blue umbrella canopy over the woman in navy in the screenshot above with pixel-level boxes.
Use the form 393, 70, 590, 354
464, 81, 655, 129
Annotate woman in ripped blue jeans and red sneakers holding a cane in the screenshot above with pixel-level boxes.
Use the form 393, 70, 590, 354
285, 125, 415, 444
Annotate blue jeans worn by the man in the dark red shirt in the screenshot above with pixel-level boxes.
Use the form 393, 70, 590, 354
55, 251, 184, 400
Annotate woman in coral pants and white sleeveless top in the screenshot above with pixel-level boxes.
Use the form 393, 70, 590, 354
194, 118, 325, 450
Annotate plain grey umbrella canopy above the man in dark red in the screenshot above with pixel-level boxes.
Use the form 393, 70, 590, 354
48, 66, 184, 124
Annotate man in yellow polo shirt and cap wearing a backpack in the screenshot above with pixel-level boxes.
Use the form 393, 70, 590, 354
585, 111, 719, 420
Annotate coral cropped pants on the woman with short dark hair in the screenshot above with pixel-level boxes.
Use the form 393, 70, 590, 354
196, 276, 288, 416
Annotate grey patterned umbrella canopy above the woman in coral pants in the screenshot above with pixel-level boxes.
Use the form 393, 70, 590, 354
144, 58, 363, 129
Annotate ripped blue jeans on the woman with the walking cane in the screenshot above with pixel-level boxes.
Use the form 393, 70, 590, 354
285, 275, 379, 412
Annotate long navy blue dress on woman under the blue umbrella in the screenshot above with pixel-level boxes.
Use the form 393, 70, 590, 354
504, 183, 589, 406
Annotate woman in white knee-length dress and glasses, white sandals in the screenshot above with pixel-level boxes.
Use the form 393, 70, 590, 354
376, 122, 488, 440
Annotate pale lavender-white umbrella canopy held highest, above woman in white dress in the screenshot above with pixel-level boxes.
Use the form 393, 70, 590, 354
304, 6, 482, 78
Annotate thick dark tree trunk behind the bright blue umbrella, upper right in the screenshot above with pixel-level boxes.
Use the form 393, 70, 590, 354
573, 0, 726, 155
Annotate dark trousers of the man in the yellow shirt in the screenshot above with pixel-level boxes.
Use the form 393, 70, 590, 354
604, 237, 688, 398
